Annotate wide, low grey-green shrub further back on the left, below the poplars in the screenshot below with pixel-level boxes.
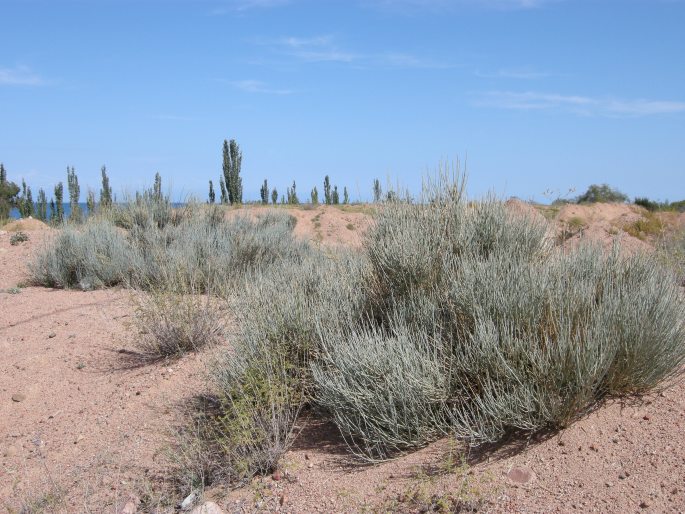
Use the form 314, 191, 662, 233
30, 201, 305, 292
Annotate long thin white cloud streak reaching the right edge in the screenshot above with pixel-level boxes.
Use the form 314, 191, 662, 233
474, 91, 685, 117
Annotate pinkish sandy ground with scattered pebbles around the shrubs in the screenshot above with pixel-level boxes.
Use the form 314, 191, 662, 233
0, 206, 685, 513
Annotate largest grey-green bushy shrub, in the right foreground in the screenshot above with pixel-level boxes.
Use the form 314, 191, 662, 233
312, 174, 685, 458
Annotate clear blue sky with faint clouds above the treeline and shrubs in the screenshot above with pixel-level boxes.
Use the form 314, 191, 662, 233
0, 0, 685, 201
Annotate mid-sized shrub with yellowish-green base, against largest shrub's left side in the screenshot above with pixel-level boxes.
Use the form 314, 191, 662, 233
198, 253, 364, 480
